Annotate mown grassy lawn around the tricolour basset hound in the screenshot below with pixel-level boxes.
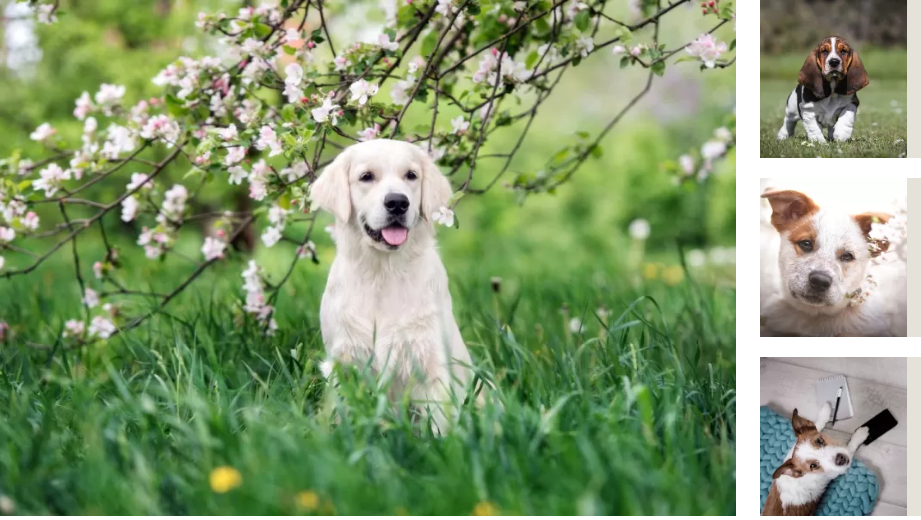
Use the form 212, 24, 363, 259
761, 50, 908, 157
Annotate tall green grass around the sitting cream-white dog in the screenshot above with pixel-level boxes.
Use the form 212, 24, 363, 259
0, 241, 736, 515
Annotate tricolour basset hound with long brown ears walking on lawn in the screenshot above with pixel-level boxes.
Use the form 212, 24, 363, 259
777, 36, 870, 143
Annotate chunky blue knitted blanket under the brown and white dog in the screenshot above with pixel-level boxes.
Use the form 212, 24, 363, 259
761, 406, 879, 516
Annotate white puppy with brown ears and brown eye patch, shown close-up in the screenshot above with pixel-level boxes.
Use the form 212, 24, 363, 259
761, 188, 907, 336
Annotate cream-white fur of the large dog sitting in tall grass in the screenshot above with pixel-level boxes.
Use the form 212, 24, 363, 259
311, 139, 472, 432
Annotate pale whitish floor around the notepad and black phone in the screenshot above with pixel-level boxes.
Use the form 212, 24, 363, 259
761, 358, 908, 516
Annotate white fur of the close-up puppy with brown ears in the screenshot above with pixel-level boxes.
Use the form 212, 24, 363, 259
761, 183, 907, 336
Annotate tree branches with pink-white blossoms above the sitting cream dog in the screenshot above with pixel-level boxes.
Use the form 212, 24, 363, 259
0, 0, 735, 348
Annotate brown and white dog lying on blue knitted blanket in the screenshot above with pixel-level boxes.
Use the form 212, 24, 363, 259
761, 403, 869, 516
